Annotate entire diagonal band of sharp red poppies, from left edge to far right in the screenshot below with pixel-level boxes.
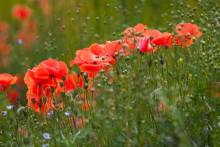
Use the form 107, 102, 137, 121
0, 23, 202, 113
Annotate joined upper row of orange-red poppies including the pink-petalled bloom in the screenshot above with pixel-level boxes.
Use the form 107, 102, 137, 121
70, 23, 202, 78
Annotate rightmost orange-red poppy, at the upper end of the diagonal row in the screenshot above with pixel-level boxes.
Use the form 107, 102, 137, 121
175, 23, 202, 47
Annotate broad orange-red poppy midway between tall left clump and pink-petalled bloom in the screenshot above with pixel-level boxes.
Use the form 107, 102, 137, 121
70, 42, 118, 78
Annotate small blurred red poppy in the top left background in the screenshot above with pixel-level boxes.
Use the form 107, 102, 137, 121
12, 5, 32, 21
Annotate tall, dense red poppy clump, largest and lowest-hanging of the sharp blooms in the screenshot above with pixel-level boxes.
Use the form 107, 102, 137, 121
24, 59, 68, 113
